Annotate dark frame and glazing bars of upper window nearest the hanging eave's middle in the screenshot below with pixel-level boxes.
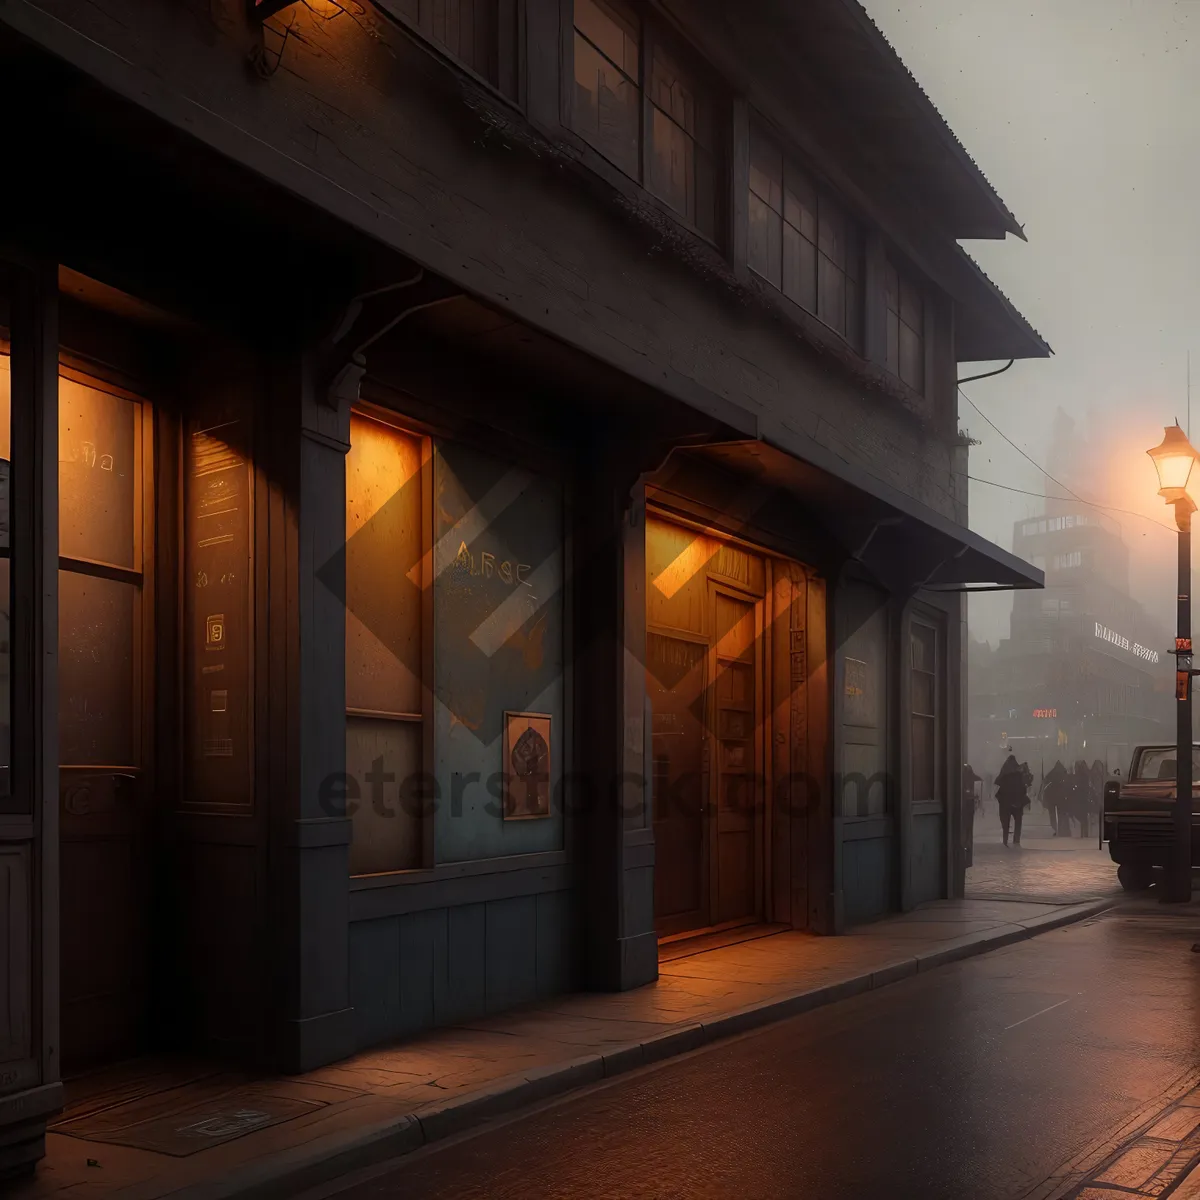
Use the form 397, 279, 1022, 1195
739, 110, 870, 352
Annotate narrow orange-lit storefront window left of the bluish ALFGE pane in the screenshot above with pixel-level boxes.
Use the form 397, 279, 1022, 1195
346, 413, 428, 875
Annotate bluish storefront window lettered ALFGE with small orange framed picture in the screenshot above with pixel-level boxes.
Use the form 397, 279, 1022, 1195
431, 442, 564, 864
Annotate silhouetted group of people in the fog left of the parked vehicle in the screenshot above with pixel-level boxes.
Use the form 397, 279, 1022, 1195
962, 751, 1108, 846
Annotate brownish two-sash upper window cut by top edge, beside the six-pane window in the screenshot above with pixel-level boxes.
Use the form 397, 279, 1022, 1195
571, 0, 718, 238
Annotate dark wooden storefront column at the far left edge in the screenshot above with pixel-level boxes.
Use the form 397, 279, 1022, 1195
0, 255, 62, 1178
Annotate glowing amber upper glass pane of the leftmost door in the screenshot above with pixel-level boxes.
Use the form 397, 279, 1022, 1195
59, 377, 142, 570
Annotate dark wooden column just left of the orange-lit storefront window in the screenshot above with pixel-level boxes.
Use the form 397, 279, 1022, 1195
271, 352, 353, 1070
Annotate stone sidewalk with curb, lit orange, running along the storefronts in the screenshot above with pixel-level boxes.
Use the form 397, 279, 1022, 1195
12, 896, 1115, 1200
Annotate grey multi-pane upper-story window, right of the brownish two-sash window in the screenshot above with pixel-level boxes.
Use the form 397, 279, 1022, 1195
749, 130, 862, 347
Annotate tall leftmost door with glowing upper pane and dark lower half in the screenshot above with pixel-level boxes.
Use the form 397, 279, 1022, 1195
59, 371, 150, 1070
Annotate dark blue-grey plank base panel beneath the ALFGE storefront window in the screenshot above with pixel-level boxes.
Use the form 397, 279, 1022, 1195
350, 890, 578, 1049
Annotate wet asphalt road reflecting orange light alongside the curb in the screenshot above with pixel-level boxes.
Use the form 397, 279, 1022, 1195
302, 899, 1200, 1200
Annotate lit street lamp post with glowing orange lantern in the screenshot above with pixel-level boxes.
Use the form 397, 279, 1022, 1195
1146, 421, 1200, 904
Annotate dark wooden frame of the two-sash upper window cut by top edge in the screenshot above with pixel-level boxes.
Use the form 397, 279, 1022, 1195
559, 0, 733, 249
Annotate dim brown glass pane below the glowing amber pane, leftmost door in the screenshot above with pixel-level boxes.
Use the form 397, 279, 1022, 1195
59, 571, 138, 767
